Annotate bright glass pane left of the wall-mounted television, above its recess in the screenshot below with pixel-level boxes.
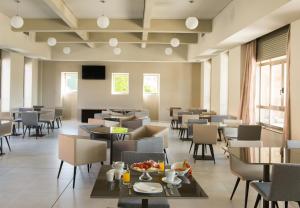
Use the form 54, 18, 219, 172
61, 72, 78, 96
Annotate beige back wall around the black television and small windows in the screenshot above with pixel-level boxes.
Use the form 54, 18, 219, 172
40, 61, 200, 120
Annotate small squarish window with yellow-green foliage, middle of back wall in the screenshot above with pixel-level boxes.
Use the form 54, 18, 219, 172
111, 73, 129, 95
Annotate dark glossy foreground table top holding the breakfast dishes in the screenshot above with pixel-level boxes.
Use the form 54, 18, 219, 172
91, 165, 208, 199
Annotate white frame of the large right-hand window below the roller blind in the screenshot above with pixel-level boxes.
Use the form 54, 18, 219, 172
255, 56, 287, 131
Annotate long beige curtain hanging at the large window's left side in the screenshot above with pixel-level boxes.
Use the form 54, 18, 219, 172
239, 40, 256, 123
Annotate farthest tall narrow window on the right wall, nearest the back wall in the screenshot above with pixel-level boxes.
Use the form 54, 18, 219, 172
203, 60, 211, 111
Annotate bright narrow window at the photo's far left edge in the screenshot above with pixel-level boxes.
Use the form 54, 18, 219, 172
1, 53, 10, 112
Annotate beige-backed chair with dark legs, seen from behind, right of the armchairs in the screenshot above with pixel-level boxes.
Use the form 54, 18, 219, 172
193, 124, 218, 164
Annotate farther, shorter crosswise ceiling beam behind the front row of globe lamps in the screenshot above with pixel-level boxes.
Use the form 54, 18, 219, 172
36, 32, 198, 44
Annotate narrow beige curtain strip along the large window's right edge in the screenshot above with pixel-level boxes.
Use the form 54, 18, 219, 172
283, 29, 291, 142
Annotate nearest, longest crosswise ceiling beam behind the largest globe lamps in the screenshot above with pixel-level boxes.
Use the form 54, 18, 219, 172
11, 19, 212, 33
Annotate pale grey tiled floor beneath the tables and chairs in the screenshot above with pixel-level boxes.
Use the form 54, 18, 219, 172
0, 121, 292, 208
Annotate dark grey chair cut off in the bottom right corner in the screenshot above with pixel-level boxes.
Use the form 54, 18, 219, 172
251, 164, 300, 208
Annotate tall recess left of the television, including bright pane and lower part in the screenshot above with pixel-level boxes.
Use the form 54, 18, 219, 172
61, 72, 78, 120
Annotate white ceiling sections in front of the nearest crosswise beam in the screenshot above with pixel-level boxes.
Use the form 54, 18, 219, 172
0, 0, 231, 19
